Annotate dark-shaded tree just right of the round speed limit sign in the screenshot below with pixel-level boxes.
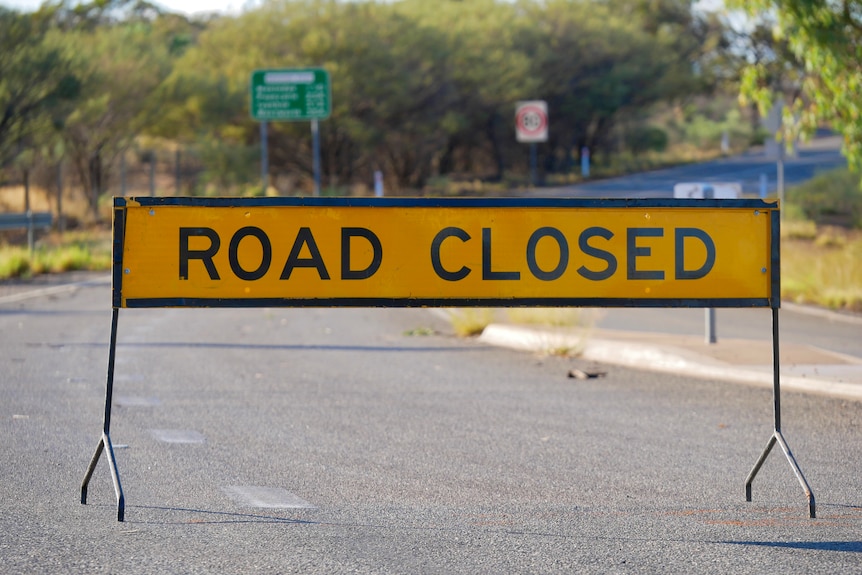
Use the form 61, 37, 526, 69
518, 0, 700, 171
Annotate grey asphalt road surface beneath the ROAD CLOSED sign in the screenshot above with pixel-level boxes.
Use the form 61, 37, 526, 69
0, 278, 862, 574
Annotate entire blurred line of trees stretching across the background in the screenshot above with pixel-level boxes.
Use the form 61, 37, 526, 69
0, 0, 859, 207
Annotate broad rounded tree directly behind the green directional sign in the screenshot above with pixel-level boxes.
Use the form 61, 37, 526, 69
166, 0, 456, 194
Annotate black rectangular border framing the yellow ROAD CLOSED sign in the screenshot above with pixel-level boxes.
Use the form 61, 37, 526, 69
112, 196, 781, 309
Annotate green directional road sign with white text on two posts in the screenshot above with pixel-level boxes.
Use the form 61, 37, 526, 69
251, 68, 332, 121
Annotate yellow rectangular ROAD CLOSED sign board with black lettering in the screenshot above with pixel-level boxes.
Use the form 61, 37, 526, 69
114, 197, 779, 307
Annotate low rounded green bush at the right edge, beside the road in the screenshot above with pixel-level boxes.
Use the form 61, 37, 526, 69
786, 170, 862, 229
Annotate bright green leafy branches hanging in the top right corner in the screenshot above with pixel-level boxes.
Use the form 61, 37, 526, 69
732, 0, 862, 170
